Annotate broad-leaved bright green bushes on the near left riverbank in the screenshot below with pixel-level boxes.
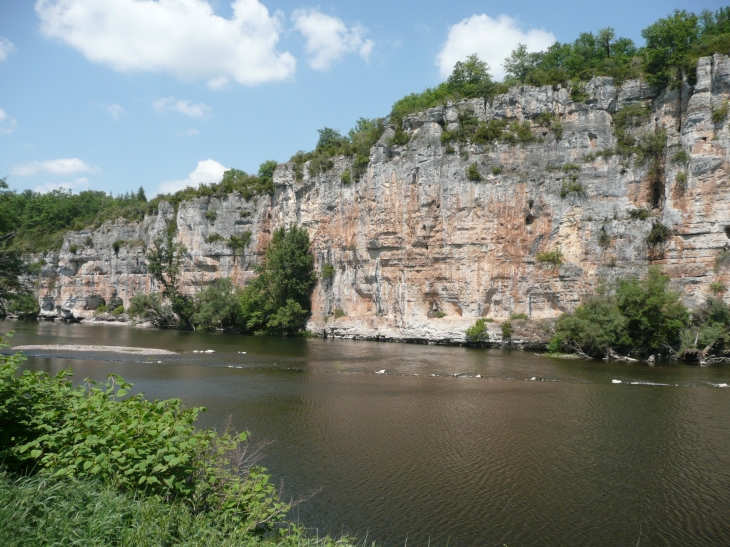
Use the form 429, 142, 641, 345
0, 346, 287, 531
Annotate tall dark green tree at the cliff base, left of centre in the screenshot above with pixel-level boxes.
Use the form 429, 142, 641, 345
241, 226, 317, 335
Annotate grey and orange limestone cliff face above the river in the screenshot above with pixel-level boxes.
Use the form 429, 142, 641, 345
39, 55, 730, 343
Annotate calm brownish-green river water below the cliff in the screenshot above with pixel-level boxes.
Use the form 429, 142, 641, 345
0, 321, 730, 547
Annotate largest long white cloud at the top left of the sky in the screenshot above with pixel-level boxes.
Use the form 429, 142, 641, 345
35, 0, 296, 88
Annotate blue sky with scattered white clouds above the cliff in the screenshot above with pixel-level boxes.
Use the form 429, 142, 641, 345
0, 0, 727, 197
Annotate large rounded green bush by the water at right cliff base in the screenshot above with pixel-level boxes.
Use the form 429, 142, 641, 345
549, 267, 689, 357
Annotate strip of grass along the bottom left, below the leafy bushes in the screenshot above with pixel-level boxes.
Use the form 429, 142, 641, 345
0, 471, 364, 547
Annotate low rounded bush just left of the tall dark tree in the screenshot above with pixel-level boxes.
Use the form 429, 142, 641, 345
192, 278, 243, 330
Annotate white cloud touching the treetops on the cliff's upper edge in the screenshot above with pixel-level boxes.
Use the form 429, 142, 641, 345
436, 14, 555, 80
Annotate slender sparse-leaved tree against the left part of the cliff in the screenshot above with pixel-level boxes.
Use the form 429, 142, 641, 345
147, 231, 195, 329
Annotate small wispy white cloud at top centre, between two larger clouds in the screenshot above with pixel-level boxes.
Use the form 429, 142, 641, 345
292, 9, 375, 70
